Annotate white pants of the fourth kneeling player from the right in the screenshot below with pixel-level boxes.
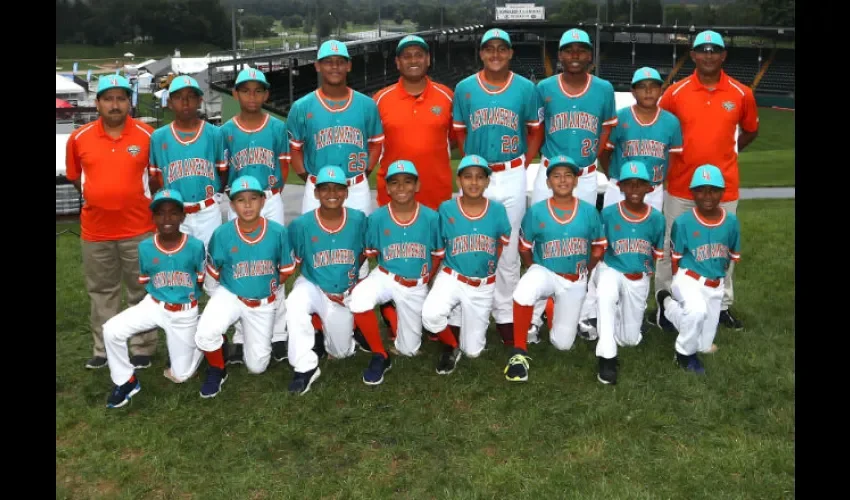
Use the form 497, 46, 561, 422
422, 267, 496, 358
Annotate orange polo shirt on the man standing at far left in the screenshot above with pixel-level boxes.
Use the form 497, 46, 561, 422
65, 117, 156, 241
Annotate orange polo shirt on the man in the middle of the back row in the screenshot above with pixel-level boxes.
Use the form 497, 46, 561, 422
374, 77, 454, 210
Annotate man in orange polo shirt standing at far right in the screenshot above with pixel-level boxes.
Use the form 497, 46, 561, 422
655, 31, 759, 330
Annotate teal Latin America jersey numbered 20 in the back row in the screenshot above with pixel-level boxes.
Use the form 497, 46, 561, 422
452, 71, 540, 163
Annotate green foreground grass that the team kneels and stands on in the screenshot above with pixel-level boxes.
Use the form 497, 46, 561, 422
56, 200, 795, 499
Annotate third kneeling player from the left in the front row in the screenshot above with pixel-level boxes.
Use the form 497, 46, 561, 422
286, 166, 366, 394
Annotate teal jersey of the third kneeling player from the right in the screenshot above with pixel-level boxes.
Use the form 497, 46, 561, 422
519, 198, 605, 274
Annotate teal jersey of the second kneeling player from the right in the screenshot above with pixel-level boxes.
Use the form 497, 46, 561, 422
600, 201, 667, 274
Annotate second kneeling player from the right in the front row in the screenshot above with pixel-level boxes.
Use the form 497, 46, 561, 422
585, 161, 666, 384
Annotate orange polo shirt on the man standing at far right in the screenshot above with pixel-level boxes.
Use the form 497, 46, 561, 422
658, 70, 759, 201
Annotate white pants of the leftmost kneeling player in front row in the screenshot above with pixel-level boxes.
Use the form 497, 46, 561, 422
103, 294, 204, 385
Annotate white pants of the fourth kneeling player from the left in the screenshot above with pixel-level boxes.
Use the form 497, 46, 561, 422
348, 267, 428, 356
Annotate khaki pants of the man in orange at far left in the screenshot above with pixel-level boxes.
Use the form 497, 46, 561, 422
81, 233, 158, 358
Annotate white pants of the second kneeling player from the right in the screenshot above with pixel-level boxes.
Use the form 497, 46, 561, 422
594, 262, 649, 359
